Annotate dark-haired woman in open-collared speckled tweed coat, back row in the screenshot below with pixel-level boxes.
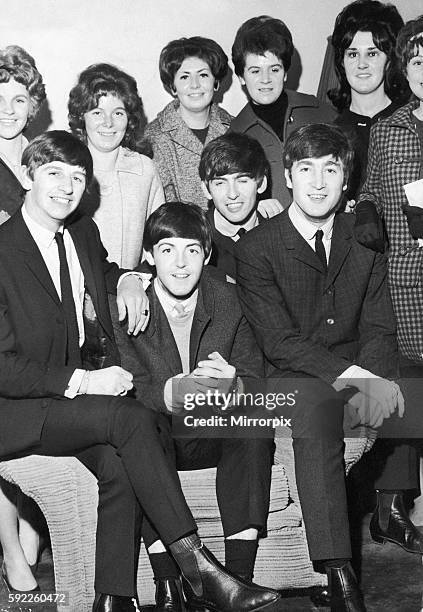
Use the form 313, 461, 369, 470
145, 36, 231, 208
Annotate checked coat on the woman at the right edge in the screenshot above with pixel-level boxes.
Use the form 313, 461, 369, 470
358, 102, 423, 362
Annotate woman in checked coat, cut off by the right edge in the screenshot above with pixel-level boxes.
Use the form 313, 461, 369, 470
358, 16, 423, 366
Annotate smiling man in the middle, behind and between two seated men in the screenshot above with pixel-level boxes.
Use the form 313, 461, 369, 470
198, 132, 269, 282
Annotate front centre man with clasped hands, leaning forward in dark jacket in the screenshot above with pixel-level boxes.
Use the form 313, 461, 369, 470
116, 202, 273, 611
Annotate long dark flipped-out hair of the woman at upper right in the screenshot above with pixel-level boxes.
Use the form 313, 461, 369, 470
328, 0, 409, 111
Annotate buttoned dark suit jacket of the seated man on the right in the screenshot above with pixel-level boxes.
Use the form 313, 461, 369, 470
235, 210, 397, 384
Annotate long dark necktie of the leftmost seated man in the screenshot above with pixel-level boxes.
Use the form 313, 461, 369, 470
54, 232, 81, 366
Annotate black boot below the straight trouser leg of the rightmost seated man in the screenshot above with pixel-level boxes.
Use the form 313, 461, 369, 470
328, 563, 366, 612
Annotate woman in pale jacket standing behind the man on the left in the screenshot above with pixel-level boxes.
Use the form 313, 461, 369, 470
68, 64, 164, 268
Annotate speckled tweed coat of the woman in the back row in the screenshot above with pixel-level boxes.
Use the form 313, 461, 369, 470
145, 100, 232, 209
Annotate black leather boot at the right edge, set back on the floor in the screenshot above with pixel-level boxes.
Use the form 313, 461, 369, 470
370, 491, 423, 555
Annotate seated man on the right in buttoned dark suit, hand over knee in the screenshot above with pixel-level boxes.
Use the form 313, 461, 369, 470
236, 124, 410, 612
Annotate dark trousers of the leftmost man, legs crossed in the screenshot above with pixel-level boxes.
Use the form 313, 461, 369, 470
30, 396, 197, 595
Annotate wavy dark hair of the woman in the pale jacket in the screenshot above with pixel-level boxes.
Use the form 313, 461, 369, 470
68, 64, 144, 150
